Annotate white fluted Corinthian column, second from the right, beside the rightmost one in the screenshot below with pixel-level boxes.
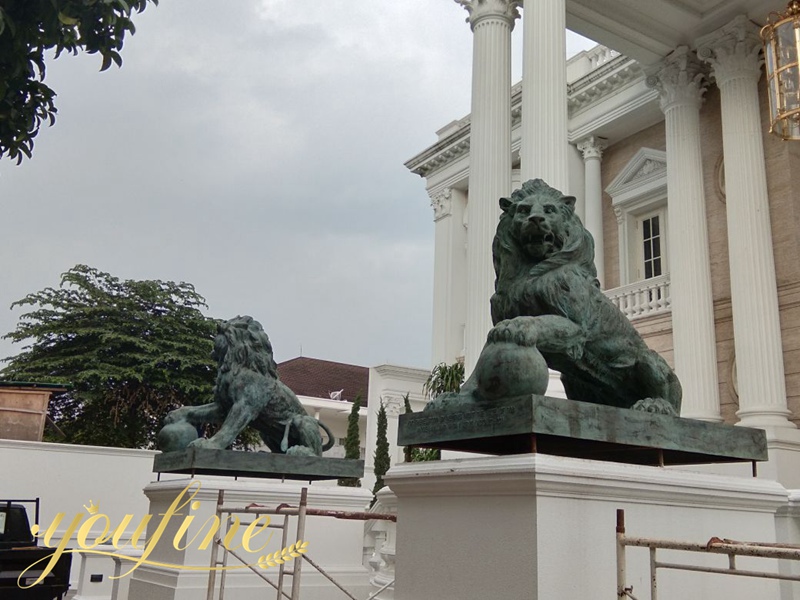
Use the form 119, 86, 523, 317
648, 46, 721, 421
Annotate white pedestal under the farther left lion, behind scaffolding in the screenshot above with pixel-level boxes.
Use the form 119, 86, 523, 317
123, 478, 372, 600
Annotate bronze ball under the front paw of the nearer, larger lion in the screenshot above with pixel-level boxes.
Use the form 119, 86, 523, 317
475, 342, 550, 400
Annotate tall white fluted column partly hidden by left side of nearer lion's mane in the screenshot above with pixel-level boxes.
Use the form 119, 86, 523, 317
456, 0, 519, 374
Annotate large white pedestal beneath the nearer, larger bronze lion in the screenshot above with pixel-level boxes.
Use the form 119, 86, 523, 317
386, 454, 787, 600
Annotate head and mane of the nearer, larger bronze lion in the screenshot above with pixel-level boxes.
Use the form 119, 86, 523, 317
492, 179, 599, 324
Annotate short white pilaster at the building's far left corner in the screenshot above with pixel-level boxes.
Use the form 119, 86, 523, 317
431, 188, 467, 365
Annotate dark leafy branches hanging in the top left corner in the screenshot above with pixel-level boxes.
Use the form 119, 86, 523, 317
0, 0, 158, 164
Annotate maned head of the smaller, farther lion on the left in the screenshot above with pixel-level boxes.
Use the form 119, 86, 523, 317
211, 316, 278, 378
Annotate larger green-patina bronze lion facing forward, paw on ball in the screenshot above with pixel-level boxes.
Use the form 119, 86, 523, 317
430, 179, 681, 416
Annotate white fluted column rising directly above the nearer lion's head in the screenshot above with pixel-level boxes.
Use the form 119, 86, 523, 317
520, 0, 570, 193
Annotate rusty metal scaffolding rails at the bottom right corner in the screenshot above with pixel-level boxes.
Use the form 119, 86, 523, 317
617, 509, 800, 600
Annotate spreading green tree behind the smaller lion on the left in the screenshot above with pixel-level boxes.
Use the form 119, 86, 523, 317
0, 265, 216, 448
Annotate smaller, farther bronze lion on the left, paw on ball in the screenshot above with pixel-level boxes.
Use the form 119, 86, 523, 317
158, 316, 334, 456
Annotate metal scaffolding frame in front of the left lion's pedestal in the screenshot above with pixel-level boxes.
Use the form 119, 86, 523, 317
206, 487, 397, 600
